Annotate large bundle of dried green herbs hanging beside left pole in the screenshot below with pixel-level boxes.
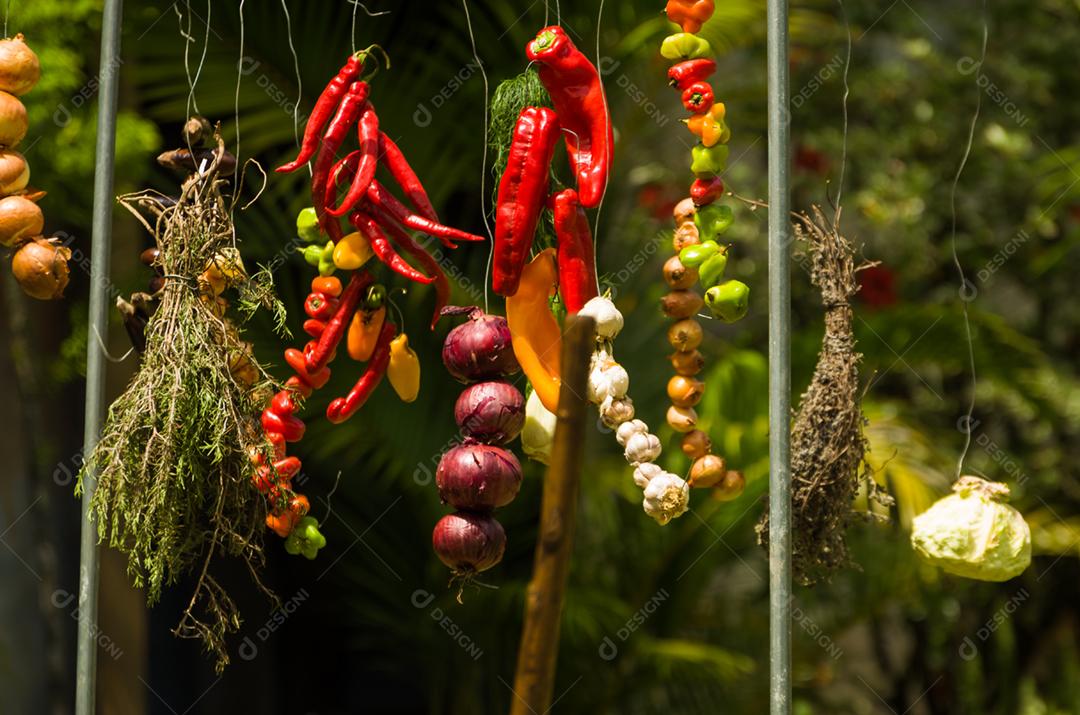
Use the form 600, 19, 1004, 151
80, 139, 281, 670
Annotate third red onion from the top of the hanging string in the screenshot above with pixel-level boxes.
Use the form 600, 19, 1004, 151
435, 444, 522, 511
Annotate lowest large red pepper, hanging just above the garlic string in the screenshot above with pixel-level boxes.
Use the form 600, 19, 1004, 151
552, 189, 599, 315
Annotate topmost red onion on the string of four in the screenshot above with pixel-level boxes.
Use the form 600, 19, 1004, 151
442, 306, 522, 382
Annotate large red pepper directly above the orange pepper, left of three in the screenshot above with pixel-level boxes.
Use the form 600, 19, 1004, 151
491, 107, 559, 297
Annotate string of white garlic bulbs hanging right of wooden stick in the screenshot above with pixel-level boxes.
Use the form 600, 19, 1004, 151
579, 296, 690, 525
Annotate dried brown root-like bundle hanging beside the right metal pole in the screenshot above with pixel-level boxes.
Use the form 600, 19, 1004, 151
757, 206, 888, 585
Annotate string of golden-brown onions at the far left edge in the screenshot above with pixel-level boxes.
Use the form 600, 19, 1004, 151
0, 33, 71, 300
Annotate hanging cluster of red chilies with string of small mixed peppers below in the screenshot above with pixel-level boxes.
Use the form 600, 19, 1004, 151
259, 45, 483, 558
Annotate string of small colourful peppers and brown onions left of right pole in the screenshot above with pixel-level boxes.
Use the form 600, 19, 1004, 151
660, 0, 747, 500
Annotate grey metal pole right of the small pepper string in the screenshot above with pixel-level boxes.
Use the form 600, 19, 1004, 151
767, 0, 792, 715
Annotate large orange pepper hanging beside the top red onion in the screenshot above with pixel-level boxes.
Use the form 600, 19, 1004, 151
507, 248, 563, 412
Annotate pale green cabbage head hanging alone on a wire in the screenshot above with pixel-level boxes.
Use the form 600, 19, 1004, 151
912, 476, 1031, 581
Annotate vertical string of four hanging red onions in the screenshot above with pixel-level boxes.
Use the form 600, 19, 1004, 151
431, 307, 525, 587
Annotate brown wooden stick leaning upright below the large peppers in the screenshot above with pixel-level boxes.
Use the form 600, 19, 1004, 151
510, 316, 596, 715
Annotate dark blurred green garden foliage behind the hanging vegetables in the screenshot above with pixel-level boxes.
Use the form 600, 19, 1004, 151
0, 0, 1080, 715
